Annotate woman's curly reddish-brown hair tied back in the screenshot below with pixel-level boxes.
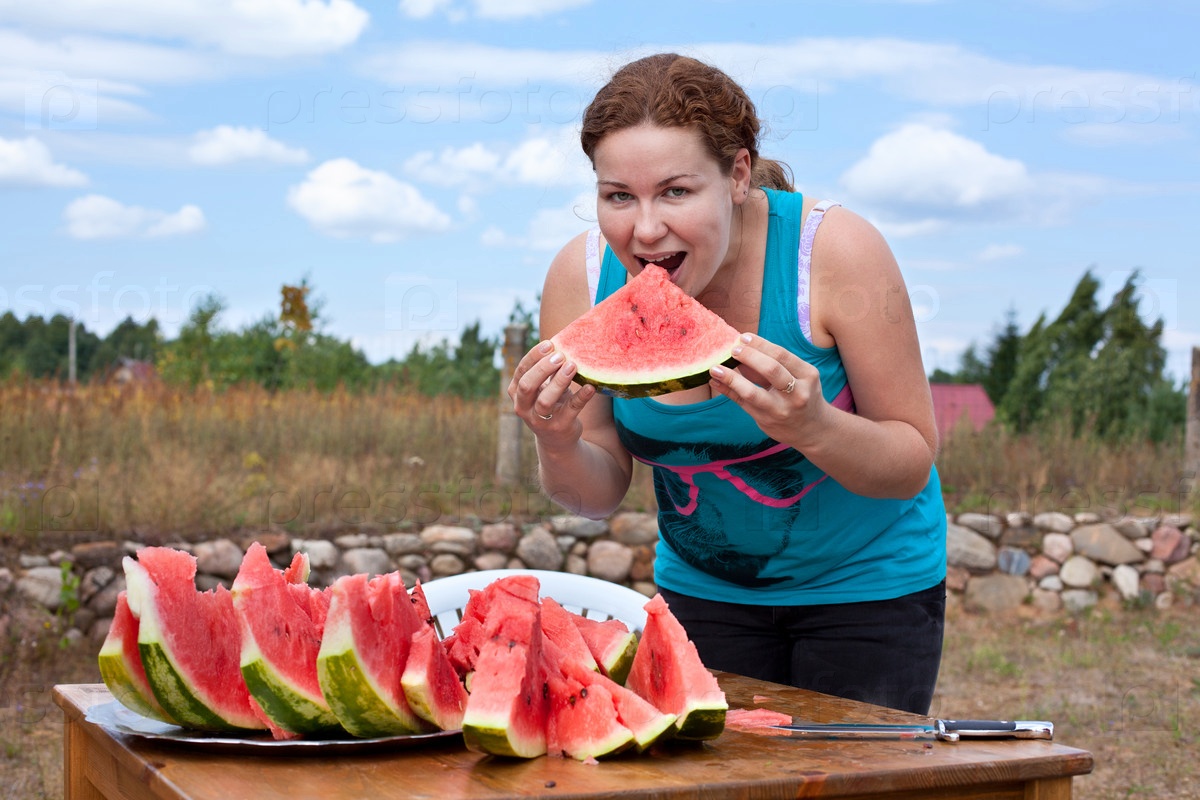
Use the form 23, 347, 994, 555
580, 53, 796, 192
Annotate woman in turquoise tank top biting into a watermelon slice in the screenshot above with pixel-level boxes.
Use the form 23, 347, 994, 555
509, 54, 946, 714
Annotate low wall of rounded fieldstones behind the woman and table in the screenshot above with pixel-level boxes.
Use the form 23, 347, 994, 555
0, 512, 1200, 640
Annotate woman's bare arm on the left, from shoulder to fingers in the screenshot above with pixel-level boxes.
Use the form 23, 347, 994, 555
509, 234, 632, 518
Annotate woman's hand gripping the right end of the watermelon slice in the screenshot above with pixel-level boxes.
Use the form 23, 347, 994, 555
709, 333, 832, 450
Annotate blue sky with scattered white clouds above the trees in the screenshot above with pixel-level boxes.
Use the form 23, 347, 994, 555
0, 0, 1200, 379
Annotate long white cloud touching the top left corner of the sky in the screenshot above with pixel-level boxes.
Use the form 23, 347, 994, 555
0, 0, 370, 58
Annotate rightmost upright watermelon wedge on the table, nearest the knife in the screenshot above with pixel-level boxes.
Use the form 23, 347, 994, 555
625, 595, 730, 739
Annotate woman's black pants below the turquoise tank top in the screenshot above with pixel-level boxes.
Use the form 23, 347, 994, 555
660, 582, 946, 714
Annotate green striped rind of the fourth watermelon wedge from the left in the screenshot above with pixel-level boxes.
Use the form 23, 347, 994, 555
317, 646, 430, 739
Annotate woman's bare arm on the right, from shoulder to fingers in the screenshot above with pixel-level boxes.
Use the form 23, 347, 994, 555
713, 209, 937, 498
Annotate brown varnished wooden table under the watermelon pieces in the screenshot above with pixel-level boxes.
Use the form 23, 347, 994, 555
54, 673, 1092, 800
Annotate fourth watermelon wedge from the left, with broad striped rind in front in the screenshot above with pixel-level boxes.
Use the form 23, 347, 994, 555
317, 572, 432, 738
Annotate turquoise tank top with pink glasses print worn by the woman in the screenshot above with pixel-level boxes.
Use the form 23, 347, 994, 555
596, 190, 946, 606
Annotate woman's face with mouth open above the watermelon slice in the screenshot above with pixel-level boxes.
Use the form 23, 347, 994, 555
593, 125, 750, 296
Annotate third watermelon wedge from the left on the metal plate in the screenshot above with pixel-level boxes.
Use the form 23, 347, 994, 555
233, 542, 340, 735
